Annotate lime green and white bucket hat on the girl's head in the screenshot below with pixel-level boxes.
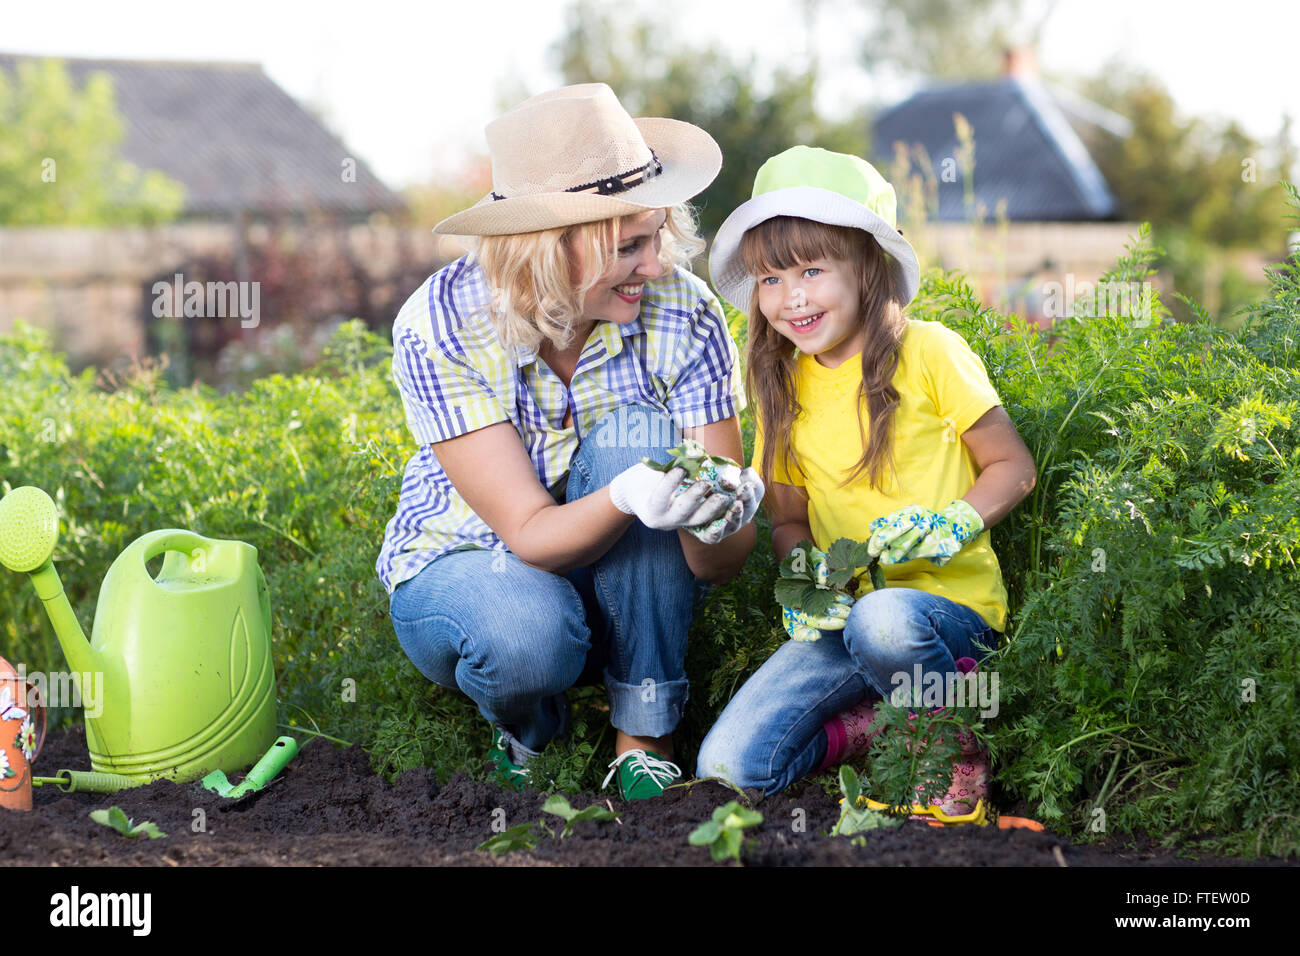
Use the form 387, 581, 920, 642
709, 146, 920, 312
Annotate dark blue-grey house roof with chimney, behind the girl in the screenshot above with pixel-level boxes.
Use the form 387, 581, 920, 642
872, 75, 1118, 221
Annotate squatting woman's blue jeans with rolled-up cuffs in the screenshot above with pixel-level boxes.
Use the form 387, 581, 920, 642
389, 406, 707, 763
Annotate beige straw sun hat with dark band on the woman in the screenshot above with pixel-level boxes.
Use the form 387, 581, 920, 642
433, 83, 723, 235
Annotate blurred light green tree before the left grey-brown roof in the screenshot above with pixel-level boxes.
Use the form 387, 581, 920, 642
0, 60, 185, 226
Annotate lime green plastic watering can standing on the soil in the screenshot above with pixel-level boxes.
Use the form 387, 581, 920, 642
0, 486, 276, 783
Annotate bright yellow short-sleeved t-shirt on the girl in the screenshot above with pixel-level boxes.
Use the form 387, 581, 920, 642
754, 320, 1006, 631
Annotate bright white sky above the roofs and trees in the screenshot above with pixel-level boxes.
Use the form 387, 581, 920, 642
0, 0, 1300, 187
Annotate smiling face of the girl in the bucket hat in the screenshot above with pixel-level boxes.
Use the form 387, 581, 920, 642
755, 258, 866, 368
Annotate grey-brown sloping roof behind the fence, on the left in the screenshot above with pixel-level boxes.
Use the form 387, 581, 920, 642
0, 53, 404, 217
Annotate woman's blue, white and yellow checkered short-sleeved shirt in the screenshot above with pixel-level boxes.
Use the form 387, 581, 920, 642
376, 256, 745, 594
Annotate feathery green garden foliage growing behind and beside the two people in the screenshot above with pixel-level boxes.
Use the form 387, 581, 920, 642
0, 190, 1300, 853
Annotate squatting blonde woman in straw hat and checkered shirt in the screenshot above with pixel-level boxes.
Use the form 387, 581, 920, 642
377, 83, 763, 799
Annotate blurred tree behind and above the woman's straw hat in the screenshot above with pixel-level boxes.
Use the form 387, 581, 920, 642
554, 0, 867, 235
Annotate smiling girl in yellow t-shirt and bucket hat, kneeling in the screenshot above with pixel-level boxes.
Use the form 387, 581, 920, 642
698, 146, 1035, 816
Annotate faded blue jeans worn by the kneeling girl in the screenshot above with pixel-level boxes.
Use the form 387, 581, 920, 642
696, 588, 998, 795
